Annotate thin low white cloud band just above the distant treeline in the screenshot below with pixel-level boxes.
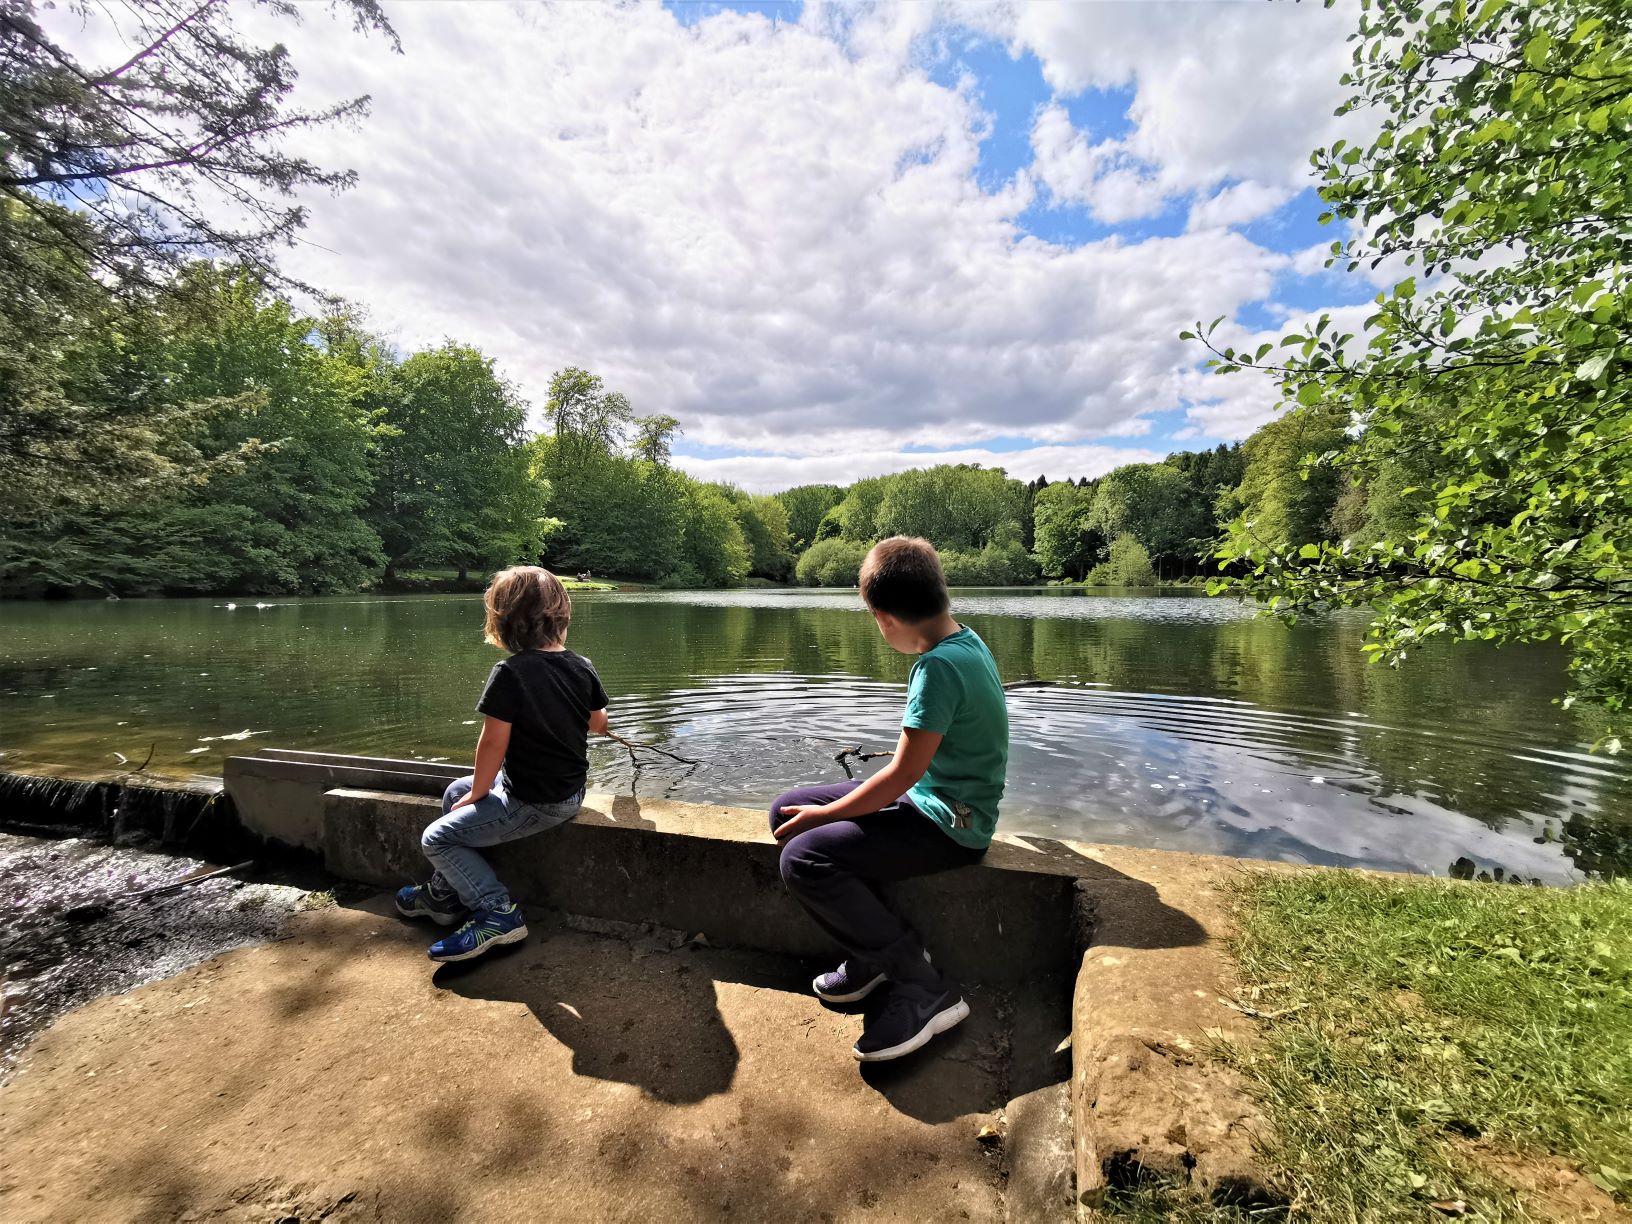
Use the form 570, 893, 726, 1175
674, 446, 1167, 493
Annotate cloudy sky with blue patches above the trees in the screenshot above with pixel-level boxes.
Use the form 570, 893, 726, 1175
57, 0, 1387, 491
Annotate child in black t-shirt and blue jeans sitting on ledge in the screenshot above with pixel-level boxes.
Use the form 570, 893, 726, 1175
397, 565, 607, 961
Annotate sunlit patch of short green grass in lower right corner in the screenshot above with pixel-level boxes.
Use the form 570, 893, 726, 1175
1216, 871, 1632, 1222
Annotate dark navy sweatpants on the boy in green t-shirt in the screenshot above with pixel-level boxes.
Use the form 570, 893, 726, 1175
770, 782, 986, 984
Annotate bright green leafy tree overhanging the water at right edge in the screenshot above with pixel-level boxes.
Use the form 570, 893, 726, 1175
1204, 0, 1632, 751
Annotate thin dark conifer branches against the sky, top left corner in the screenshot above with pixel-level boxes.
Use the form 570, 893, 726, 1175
0, 0, 400, 295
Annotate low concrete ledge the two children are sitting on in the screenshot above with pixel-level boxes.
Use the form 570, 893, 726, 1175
322, 787, 1083, 984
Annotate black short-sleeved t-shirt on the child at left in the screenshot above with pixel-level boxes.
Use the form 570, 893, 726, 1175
477, 650, 607, 803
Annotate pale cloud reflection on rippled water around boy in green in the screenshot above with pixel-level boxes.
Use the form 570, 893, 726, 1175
596, 672, 1627, 881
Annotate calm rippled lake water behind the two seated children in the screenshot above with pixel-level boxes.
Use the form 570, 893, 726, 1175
0, 591, 1632, 881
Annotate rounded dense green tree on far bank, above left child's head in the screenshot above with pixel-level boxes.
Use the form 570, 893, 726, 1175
369, 341, 543, 576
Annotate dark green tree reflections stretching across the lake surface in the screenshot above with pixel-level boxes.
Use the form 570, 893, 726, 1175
12, 596, 1632, 871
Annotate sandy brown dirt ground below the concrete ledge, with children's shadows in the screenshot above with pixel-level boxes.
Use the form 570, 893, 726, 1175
0, 898, 1069, 1222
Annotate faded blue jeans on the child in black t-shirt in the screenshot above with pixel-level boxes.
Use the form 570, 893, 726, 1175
419, 774, 584, 911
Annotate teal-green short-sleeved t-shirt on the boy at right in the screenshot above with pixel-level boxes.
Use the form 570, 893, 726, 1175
901, 627, 1009, 847
